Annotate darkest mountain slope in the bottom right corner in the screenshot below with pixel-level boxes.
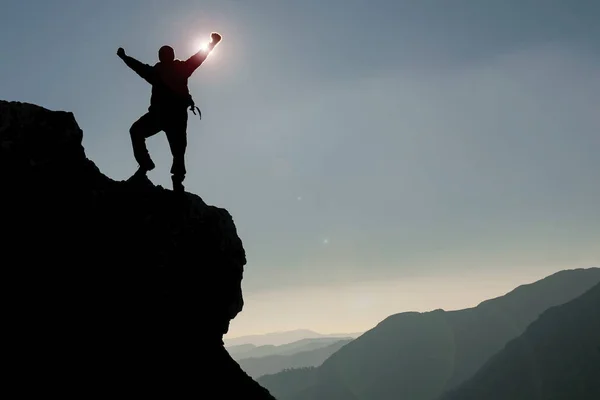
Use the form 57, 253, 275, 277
442, 284, 600, 400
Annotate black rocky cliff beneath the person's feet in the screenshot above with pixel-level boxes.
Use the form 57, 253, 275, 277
0, 101, 273, 399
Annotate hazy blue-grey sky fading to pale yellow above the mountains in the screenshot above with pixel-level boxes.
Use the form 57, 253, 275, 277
0, 0, 600, 336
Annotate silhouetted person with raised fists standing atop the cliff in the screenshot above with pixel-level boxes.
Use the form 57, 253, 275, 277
117, 32, 221, 191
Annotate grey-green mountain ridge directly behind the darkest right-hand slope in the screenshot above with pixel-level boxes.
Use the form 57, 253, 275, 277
258, 268, 600, 400
